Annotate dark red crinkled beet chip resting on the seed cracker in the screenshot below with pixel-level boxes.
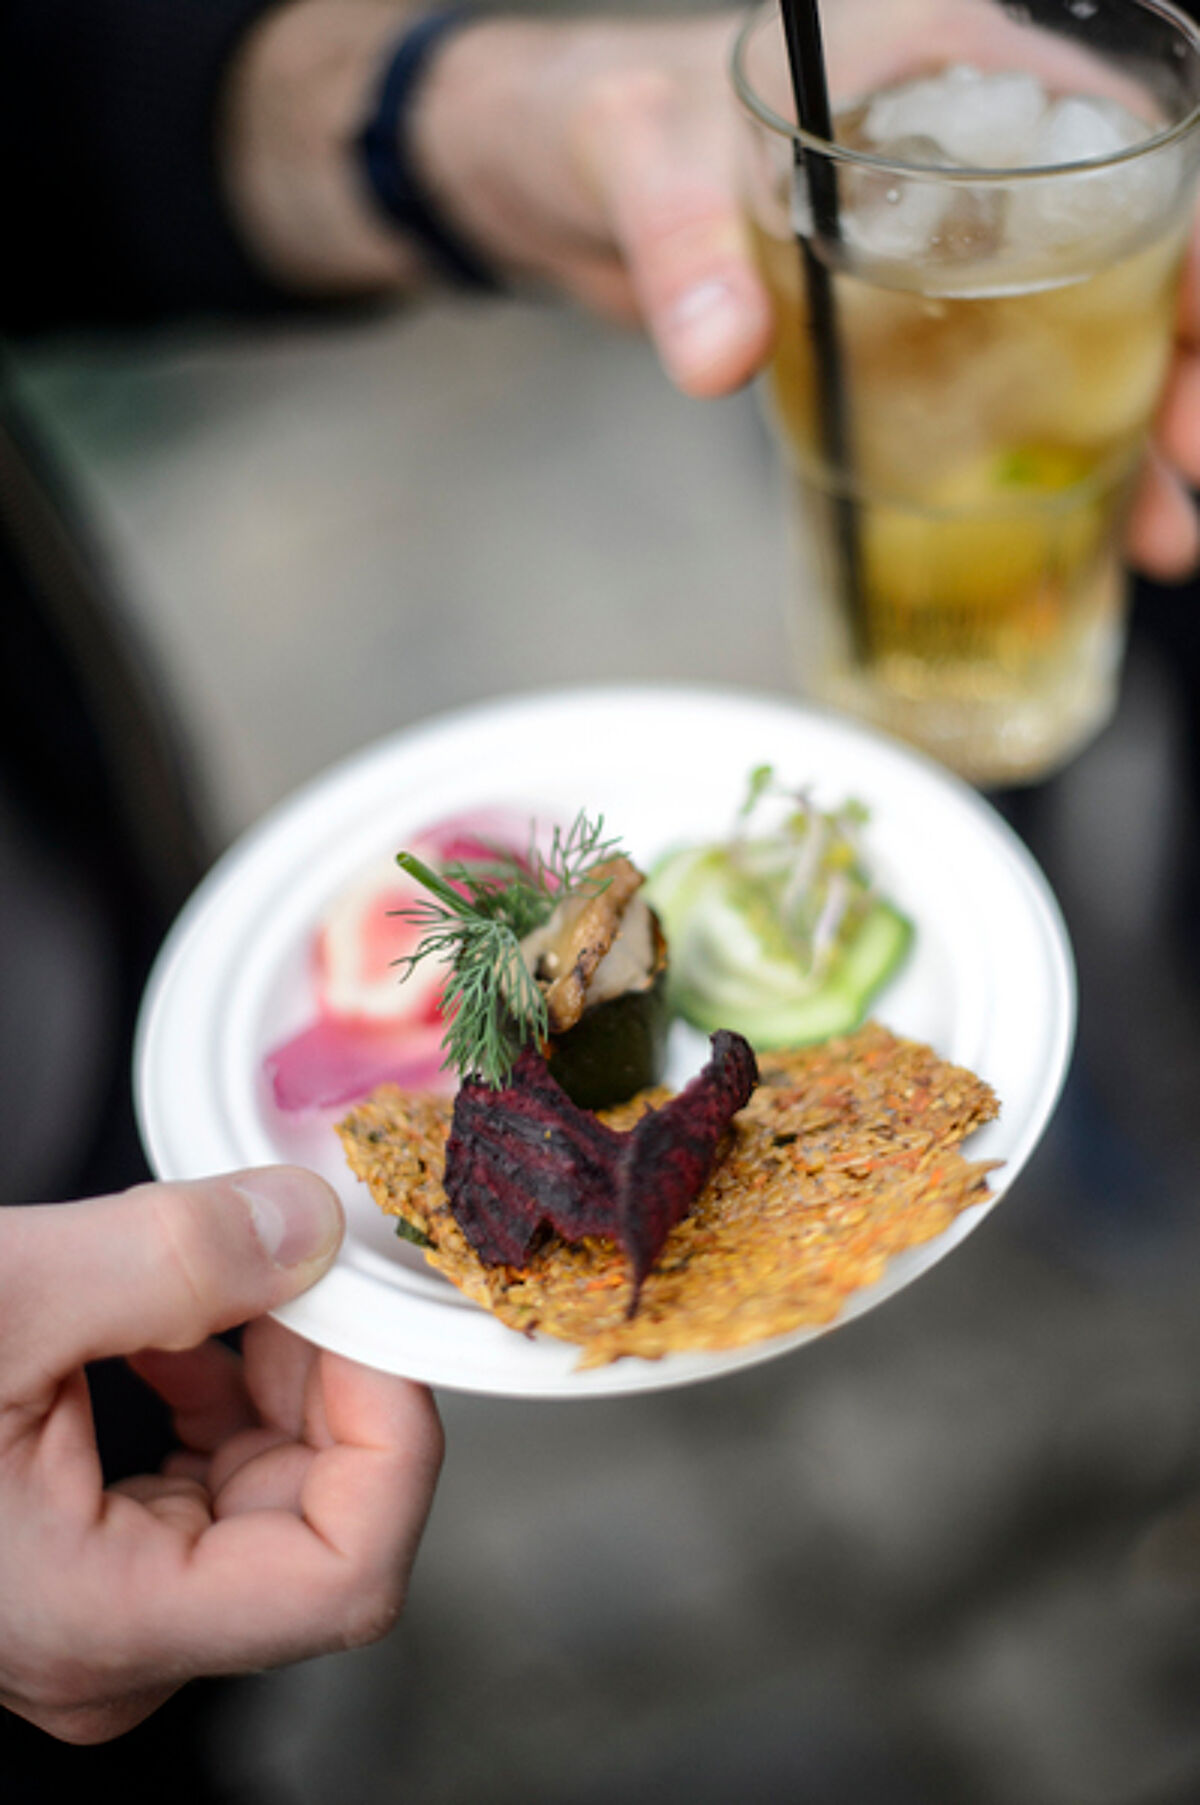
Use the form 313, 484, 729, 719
444, 1031, 758, 1301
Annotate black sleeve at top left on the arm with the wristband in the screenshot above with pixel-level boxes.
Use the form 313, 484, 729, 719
0, 0, 297, 332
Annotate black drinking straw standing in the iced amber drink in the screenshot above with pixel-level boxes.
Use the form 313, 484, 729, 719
780, 0, 870, 662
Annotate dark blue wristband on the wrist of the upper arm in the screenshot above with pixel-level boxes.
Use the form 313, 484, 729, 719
359, 7, 500, 292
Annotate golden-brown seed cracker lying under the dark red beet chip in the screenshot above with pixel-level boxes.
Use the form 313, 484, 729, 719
337, 1022, 998, 1366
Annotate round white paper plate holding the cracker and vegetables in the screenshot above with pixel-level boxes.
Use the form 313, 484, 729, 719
135, 686, 1075, 1399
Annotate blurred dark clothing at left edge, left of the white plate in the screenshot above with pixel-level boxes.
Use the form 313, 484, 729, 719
0, 379, 209, 1202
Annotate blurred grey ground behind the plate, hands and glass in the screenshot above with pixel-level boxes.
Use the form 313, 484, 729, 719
11, 7, 1200, 1805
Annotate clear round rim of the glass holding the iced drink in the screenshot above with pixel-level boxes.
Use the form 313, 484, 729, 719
729, 0, 1200, 184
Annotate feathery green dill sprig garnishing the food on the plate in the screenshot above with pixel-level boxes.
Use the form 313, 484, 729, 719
395, 810, 621, 1088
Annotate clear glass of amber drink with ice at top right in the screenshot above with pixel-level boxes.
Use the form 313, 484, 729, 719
734, 0, 1200, 785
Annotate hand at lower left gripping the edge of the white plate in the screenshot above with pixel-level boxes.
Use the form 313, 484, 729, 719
0, 1168, 440, 1742
